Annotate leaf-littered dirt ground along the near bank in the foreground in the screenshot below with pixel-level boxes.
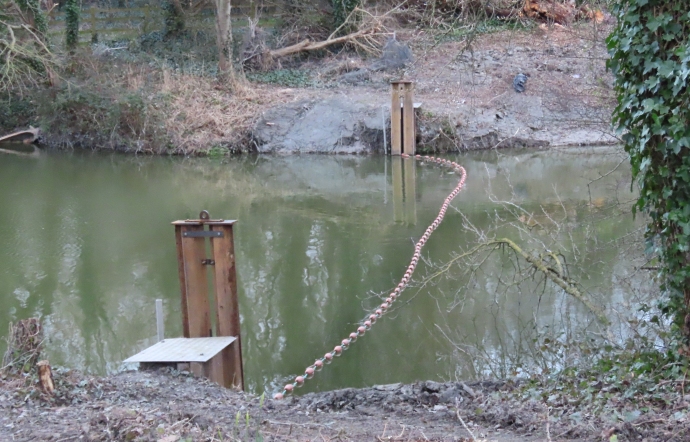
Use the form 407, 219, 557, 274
0, 369, 690, 442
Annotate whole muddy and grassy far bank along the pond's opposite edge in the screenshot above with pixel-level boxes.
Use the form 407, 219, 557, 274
0, 24, 618, 155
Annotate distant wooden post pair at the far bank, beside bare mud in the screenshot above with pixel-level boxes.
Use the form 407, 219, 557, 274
391, 80, 415, 155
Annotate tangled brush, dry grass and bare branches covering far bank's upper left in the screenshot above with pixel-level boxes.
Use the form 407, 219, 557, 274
0, 0, 612, 155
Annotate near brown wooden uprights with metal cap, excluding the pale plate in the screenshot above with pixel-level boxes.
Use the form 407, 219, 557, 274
173, 211, 244, 390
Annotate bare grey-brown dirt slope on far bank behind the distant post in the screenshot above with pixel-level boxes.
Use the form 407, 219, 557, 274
282, 22, 619, 150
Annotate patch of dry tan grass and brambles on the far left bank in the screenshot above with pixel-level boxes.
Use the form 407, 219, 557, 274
41, 53, 306, 155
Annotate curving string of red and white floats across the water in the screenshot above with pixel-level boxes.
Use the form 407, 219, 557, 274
273, 154, 467, 400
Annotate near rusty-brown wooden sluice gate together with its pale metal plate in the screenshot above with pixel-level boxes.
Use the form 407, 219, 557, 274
124, 211, 244, 390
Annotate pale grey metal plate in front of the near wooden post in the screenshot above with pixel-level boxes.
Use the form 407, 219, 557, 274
125, 336, 237, 362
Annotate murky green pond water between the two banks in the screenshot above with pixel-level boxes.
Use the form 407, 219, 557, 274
0, 148, 640, 394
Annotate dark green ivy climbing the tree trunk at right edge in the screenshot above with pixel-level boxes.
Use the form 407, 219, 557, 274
607, 0, 690, 343
